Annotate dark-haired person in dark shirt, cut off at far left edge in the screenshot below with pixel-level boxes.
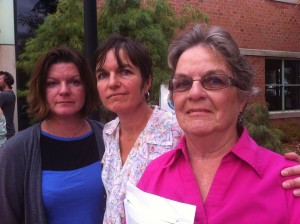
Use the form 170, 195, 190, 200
0, 71, 16, 139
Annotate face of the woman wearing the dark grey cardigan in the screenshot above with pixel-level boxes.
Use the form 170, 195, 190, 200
46, 62, 85, 118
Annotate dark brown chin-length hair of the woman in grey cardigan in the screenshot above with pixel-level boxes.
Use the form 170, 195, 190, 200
27, 46, 99, 121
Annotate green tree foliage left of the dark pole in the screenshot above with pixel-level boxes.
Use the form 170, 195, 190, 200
17, 0, 84, 75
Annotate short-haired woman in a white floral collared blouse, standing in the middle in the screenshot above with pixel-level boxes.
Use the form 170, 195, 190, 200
95, 34, 182, 224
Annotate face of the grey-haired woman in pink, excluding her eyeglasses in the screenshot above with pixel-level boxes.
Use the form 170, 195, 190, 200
173, 46, 245, 136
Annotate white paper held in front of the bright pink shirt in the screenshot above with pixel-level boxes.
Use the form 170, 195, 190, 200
124, 182, 196, 224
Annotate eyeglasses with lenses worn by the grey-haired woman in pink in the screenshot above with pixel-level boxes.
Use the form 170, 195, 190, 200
169, 74, 237, 92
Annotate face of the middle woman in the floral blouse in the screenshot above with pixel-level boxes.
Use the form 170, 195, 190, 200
96, 50, 150, 115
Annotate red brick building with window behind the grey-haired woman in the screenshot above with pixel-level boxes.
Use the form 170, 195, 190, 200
99, 0, 300, 125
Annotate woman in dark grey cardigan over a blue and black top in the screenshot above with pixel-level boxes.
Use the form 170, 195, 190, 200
0, 46, 105, 224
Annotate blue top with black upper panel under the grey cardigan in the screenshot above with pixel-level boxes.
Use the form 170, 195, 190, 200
41, 131, 104, 224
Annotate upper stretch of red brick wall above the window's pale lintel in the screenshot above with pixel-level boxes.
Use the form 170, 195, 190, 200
171, 0, 300, 51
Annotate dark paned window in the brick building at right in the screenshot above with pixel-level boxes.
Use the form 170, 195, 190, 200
265, 59, 300, 111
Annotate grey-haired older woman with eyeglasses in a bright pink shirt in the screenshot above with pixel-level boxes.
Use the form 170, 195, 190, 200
137, 24, 300, 224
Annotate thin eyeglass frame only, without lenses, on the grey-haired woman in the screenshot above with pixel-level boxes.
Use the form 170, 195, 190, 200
168, 73, 240, 93
